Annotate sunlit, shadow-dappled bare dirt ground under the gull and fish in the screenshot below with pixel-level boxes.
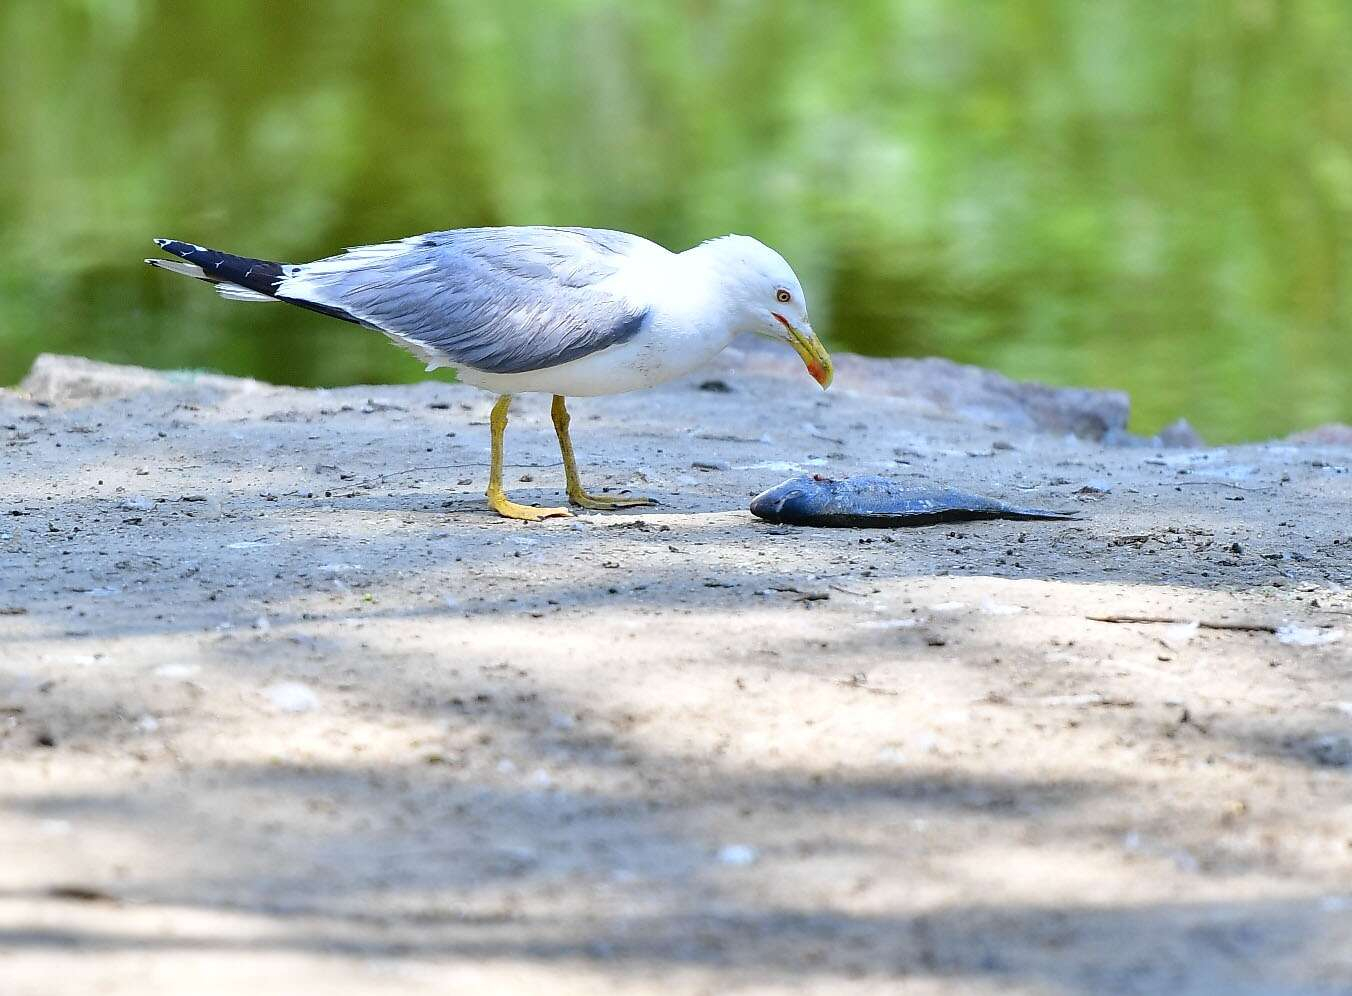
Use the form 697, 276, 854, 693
0, 355, 1352, 996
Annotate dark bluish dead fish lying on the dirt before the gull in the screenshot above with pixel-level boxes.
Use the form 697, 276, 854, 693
752, 474, 1075, 528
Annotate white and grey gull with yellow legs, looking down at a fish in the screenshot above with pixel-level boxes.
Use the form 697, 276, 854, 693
146, 226, 831, 522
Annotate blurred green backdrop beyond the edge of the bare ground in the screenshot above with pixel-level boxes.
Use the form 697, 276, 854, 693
0, 0, 1352, 442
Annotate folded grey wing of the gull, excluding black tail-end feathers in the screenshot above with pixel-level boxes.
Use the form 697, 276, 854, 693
277, 227, 654, 373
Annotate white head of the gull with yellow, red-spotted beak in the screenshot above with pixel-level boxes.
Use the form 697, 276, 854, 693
702, 235, 834, 389
